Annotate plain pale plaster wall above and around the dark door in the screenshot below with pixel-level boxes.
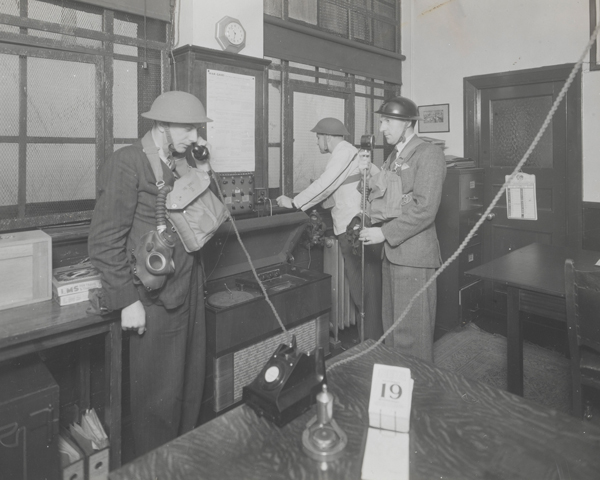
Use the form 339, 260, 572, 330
402, 0, 600, 202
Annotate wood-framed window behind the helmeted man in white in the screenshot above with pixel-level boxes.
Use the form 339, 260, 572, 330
268, 58, 400, 198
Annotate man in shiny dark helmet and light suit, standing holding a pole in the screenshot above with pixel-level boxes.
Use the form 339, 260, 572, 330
359, 97, 446, 362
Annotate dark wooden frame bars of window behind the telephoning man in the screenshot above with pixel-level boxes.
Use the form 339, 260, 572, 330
0, 0, 172, 232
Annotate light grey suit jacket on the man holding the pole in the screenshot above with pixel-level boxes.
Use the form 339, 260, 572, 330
381, 135, 446, 268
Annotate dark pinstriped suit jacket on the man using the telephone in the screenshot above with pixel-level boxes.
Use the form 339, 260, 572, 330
88, 140, 195, 310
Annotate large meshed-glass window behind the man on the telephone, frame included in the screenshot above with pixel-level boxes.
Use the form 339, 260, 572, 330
0, 0, 169, 231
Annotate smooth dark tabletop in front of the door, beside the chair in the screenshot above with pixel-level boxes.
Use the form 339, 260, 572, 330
465, 243, 600, 297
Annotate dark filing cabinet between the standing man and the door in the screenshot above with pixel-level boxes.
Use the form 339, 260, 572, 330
435, 168, 483, 338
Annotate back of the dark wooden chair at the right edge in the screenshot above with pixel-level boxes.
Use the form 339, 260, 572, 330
565, 259, 600, 355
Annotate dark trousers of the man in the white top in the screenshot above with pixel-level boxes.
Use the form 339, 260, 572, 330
337, 233, 383, 340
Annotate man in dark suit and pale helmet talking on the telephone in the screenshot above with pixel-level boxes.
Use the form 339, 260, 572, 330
88, 91, 211, 456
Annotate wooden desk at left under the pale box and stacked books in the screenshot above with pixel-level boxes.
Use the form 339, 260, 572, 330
0, 300, 121, 468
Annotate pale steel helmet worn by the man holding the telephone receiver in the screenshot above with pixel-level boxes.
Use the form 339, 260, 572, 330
142, 90, 212, 124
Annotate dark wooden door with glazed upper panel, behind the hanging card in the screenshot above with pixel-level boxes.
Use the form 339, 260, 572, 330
480, 82, 566, 255
